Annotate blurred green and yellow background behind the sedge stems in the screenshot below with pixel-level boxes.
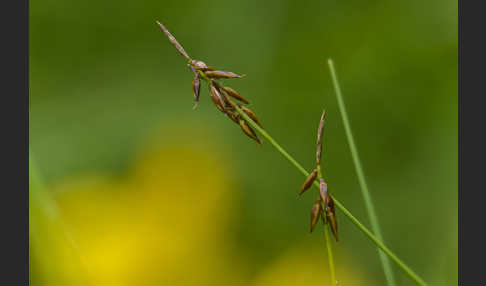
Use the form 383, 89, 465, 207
30, 0, 458, 286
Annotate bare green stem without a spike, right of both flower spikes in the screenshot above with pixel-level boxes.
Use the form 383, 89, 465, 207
328, 59, 396, 286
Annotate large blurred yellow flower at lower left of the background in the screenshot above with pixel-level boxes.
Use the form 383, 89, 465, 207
33, 135, 243, 286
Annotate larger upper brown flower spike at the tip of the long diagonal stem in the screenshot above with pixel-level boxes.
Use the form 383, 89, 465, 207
156, 21, 262, 144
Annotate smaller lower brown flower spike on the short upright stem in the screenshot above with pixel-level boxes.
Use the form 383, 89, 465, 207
299, 110, 338, 241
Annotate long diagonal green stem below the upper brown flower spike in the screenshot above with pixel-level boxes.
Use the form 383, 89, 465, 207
233, 105, 427, 286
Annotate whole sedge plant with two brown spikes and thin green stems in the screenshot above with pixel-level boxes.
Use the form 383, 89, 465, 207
156, 21, 427, 285
